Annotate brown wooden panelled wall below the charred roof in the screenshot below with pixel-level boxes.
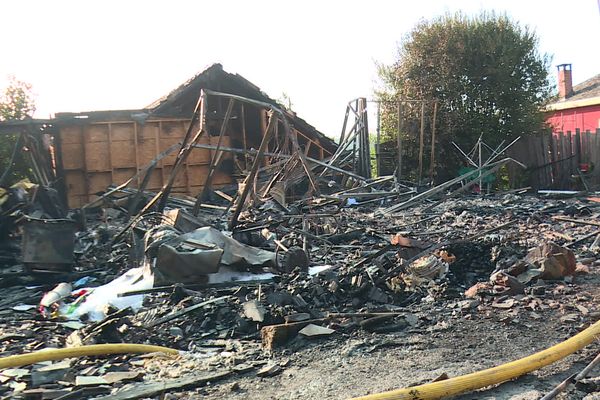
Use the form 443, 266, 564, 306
59, 115, 262, 207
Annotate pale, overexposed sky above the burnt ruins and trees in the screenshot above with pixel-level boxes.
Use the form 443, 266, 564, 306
0, 0, 600, 136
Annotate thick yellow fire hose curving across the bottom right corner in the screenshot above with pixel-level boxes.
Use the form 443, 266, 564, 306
354, 321, 600, 400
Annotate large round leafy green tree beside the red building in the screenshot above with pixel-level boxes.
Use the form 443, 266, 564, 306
376, 13, 552, 178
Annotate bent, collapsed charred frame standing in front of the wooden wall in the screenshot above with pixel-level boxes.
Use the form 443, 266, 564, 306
111, 90, 353, 237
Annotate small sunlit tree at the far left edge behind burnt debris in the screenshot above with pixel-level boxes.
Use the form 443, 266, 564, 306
0, 76, 35, 185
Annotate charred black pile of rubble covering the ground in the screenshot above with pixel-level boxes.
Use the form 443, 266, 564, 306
0, 178, 600, 399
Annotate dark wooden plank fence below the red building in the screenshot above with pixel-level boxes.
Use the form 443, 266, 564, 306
508, 128, 600, 190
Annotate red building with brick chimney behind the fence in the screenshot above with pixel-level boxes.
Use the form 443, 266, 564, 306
546, 64, 600, 133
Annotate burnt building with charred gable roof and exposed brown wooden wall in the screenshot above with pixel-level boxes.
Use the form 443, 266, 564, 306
52, 64, 337, 207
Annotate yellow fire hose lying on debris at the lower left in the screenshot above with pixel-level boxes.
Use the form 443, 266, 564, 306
0, 343, 179, 369
